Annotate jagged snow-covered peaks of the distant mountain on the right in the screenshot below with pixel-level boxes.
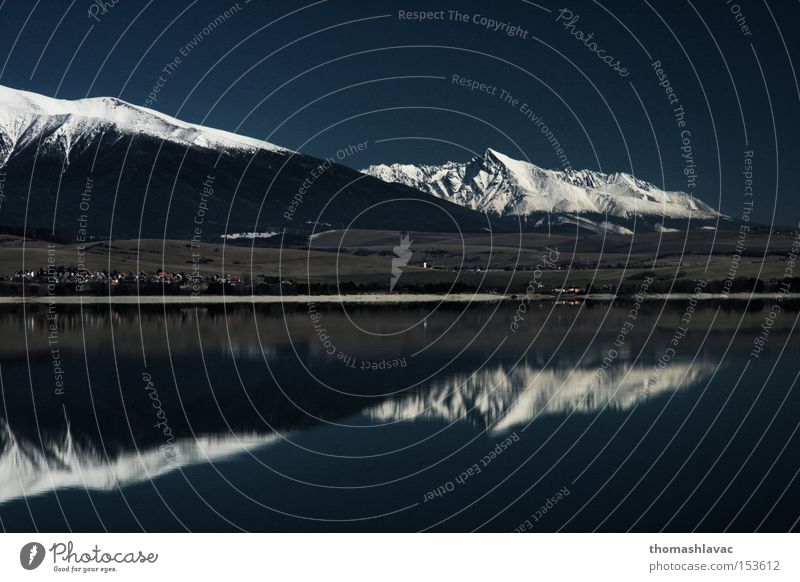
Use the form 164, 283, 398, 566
362, 149, 719, 219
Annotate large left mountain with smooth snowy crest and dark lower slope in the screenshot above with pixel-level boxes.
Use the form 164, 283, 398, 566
0, 87, 496, 242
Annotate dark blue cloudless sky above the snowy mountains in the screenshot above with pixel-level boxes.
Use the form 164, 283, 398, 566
0, 0, 800, 225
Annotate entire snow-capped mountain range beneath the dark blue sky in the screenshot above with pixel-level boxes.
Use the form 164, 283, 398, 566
0, 86, 725, 244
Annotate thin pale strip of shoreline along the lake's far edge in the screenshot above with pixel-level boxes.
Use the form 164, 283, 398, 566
0, 293, 800, 305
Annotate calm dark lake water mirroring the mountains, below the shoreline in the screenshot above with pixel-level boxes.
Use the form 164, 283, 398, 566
0, 300, 800, 531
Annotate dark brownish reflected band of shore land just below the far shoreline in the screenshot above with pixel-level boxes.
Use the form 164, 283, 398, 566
0, 299, 800, 357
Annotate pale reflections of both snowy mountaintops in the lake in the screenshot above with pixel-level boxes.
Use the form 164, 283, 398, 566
0, 364, 713, 503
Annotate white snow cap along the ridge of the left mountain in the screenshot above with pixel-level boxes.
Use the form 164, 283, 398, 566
0, 85, 291, 161
